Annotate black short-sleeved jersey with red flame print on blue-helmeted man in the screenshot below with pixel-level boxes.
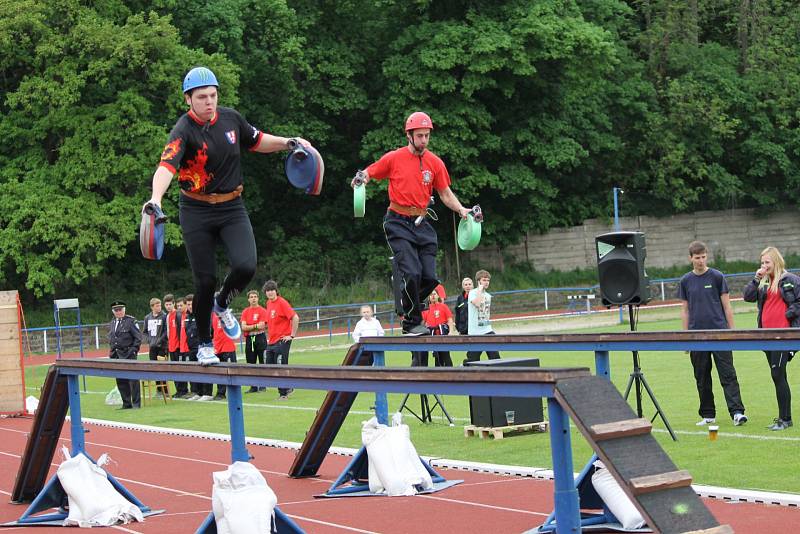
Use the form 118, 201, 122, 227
159, 107, 264, 193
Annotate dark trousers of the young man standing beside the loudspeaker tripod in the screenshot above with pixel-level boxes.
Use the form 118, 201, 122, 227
690, 350, 744, 419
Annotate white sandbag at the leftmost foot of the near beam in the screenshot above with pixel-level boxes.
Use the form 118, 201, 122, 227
56, 447, 144, 528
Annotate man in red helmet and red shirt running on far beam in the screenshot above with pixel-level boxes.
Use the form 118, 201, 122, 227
351, 111, 470, 335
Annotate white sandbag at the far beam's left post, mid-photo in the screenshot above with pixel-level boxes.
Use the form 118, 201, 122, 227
361, 413, 433, 496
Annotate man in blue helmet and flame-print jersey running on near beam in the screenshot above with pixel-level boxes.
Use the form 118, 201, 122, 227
145, 67, 308, 365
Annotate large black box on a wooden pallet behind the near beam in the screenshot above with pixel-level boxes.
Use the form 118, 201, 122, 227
464, 358, 544, 428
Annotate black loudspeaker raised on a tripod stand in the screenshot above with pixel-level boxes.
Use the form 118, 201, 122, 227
594, 232, 650, 306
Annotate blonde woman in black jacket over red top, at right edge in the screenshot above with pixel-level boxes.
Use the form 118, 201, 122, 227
744, 247, 800, 430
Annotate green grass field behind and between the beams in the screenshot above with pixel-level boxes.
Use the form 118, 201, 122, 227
21, 305, 800, 493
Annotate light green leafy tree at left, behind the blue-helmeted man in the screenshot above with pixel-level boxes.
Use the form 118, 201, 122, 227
0, 0, 236, 296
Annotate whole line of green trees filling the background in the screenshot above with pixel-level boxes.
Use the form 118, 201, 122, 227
0, 0, 800, 318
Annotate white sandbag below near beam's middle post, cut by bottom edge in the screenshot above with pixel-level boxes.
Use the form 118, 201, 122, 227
211, 462, 278, 534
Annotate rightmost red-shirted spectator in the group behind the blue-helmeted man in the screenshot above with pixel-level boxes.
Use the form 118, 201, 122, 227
264, 280, 300, 400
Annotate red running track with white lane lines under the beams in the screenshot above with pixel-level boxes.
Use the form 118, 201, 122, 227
0, 417, 800, 534
